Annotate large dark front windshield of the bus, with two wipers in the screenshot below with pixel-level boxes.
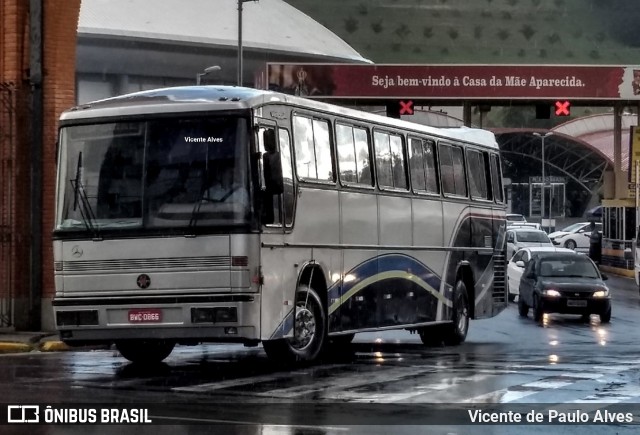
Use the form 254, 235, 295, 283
56, 116, 252, 232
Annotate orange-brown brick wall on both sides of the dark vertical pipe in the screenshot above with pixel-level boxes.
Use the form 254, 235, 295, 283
0, 0, 80, 329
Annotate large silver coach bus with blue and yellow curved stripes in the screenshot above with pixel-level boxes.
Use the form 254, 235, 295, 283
53, 86, 507, 363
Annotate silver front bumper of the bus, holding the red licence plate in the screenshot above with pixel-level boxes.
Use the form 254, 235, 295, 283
53, 294, 260, 345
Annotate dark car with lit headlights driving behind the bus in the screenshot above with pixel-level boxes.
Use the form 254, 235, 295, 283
518, 253, 611, 323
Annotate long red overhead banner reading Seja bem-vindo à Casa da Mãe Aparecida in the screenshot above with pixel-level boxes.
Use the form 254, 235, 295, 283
267, 63, 640, 100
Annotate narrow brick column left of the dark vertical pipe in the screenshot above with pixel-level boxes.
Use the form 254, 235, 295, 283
0, 0, 30, 328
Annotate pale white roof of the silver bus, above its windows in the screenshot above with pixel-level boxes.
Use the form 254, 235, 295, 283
60, 86, 498, 149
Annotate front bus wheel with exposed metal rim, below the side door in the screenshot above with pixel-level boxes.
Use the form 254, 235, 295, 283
262, 286, 327, 364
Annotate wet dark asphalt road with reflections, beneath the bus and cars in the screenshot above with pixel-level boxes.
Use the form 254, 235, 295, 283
0, 276, 640, 435
